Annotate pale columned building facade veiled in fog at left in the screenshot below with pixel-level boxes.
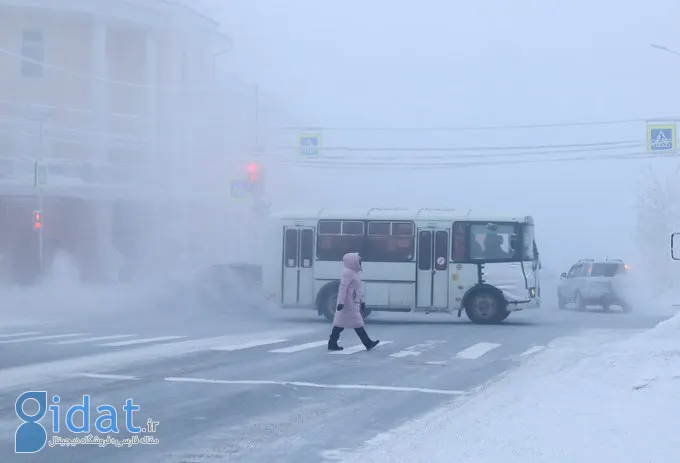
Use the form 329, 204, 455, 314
0, 0, 252, 282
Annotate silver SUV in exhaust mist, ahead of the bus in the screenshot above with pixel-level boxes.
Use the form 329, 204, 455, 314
557, 259, 633, 313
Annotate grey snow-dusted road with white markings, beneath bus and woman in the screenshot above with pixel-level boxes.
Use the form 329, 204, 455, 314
0, 308, 670, 463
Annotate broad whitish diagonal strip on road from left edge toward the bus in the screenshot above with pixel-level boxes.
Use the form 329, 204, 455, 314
0, 328, 314, 390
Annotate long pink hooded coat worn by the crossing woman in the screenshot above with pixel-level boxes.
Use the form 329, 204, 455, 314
333, 252, 364, 328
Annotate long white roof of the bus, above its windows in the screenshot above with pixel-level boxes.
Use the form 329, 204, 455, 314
272, 207, 533, 223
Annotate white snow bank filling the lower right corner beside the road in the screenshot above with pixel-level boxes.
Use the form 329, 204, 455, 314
341, 314, 680, 463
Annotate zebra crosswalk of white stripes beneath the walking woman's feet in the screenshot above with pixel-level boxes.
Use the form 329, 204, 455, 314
0, 331, 545, 365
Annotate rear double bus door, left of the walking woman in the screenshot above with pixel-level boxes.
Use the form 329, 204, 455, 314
281, 227, 314, 306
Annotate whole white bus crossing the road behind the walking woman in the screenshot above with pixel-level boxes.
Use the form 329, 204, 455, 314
262, 208, 540, 324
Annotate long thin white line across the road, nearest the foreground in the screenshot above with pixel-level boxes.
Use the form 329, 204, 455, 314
163, 378, 467, 395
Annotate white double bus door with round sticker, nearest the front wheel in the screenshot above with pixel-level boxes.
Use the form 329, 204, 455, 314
416, 229, 449, 309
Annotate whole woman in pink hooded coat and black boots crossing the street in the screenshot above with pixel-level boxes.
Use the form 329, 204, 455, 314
328, 252, 380, 351
